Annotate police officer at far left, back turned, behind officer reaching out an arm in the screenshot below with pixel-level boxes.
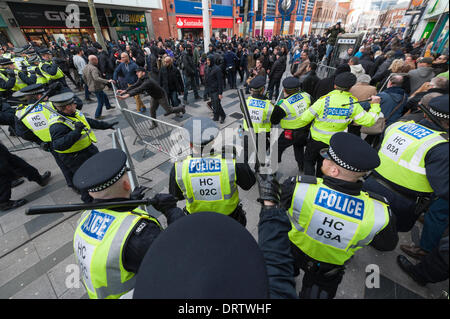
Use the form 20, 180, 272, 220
13, 84, 74, 188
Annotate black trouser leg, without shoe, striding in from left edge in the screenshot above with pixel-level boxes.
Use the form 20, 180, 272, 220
0, 144, 42, 203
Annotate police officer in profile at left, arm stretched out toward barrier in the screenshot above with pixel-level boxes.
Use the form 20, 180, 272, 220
49, 92, 118, 202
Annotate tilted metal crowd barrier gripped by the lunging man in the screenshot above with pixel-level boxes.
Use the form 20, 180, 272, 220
113, 85, 189, 159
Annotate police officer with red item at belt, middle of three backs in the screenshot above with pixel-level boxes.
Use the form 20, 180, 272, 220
270, 76, 311, 171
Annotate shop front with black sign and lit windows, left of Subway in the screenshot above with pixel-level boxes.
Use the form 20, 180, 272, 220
8, 2, 110, 45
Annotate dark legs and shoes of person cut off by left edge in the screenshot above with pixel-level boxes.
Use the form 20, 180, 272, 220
0, 143, 51, 212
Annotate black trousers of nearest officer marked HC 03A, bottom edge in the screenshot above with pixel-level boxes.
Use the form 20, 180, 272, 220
291, 243, 345, 299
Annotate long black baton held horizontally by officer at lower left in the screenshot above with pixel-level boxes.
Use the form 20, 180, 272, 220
25, 198, 156, 215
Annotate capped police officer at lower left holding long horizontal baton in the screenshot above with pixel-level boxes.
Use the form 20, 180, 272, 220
73, 149, 184, 299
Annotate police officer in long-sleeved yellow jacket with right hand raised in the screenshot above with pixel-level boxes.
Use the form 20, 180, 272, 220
299, 72, 381, 176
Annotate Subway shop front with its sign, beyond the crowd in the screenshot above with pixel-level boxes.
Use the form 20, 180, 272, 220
105, 9, 148, 45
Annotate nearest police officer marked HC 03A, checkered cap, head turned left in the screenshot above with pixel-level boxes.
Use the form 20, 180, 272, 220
281, 132, 398, 299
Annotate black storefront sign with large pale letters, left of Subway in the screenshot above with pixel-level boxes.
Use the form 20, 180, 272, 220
8, 2, 108, 28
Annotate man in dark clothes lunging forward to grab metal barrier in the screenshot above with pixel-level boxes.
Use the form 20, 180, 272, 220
117, 67, 186, 129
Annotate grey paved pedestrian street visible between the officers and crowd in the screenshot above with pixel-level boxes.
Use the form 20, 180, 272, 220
0, 84, 449, 299
